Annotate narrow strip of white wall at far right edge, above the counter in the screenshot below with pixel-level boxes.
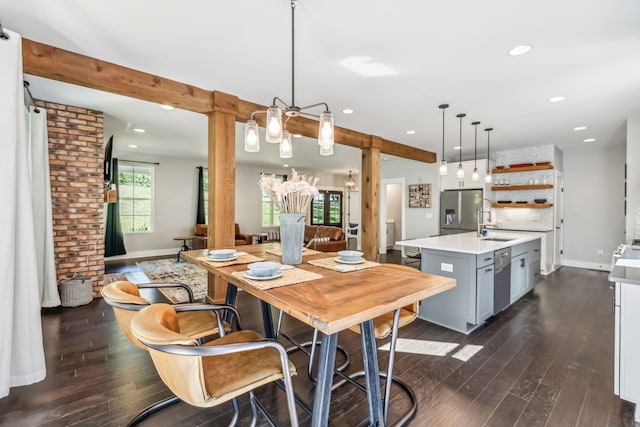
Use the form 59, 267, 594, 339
625, 116, 640, 243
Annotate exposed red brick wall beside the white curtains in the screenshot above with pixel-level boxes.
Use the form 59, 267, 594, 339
36, 101, 104, 296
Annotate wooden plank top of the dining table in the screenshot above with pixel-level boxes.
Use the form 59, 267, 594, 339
182, 243, 456, 334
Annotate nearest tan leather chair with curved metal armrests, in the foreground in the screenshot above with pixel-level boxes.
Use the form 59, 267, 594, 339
131, 304, 298, 426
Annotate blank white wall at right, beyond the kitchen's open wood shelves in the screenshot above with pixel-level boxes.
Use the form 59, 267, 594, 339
563, 144, 625, 269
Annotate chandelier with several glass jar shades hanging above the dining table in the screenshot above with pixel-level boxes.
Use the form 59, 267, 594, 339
244, 0, 335, 158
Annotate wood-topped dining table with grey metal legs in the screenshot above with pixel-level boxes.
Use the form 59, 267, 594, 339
182, 243, 456, 427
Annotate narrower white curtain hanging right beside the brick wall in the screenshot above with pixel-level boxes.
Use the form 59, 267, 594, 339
25, 106, 60, 307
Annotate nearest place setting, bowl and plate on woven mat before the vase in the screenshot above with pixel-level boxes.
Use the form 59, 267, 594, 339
231, 261, 323, 289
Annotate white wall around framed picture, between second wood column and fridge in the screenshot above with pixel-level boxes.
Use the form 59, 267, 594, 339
380, 154, 440, 240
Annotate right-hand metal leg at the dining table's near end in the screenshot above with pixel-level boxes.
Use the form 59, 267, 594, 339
360, 320, 385, 426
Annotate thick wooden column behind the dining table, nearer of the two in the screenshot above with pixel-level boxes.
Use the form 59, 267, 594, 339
207, 91, 238, 303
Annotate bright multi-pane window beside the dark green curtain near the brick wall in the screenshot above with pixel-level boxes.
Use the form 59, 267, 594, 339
118, 163, 153, 233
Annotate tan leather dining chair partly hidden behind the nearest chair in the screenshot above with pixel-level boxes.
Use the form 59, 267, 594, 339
100, 281, 242, 426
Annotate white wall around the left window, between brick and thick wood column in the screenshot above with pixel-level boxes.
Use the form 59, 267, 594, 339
110, 152, 206, 259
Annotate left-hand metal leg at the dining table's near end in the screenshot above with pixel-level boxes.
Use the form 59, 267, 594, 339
311, 334, 338, 427
